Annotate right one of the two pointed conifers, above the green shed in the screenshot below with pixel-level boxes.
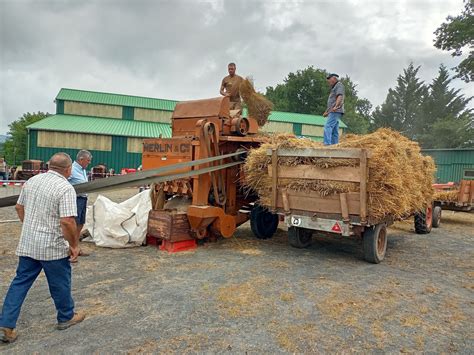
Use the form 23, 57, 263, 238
417, 65, 474, 148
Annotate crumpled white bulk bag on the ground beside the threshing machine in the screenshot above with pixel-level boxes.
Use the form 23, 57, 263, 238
84, 190, 151, 248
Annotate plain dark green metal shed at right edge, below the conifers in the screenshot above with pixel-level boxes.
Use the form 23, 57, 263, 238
422, 149, 474, 183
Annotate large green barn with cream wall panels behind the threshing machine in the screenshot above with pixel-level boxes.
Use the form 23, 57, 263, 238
27, 88, 346, 172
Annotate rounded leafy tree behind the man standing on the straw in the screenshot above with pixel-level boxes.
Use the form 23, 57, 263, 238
265, 66, 372, 133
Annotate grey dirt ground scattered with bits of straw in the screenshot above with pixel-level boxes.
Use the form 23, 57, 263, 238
0, 190, 474, 354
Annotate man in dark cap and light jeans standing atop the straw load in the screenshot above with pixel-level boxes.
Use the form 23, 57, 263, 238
323, 74, 345, 145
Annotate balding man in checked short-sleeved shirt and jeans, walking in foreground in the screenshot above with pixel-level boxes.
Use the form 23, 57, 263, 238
0, 153, 85, 343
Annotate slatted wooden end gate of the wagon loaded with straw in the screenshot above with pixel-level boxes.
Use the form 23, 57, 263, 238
267, 148, 370, 225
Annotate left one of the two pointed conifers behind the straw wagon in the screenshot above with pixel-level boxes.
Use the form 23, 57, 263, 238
372, 63, 428, 139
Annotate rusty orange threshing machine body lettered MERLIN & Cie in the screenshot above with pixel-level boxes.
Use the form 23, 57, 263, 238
142, 97, 261, 239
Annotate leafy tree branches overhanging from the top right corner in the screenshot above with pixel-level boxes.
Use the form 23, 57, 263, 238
434, 0, 474, 82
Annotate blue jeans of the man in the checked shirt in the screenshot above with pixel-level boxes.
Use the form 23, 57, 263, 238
0, 256, 74, 328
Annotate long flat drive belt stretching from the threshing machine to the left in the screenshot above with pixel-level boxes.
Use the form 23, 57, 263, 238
0, 152, 245, 207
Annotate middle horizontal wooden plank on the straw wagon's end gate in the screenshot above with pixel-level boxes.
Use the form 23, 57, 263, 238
268, 165, 361, 182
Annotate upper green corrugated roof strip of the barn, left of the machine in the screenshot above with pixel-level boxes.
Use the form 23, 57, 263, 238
56, 88, 178, 111
